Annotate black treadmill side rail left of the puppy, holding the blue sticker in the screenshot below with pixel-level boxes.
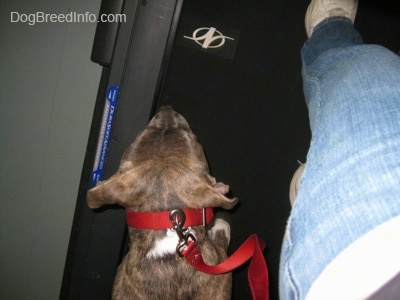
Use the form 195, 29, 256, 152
60, 0, 182, 299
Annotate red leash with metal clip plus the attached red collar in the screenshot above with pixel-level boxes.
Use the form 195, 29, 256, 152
126, 208, 269, 300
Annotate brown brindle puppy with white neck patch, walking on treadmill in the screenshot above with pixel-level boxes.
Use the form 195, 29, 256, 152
87, 107, 237, 299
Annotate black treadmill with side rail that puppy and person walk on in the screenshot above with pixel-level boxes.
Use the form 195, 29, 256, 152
60, 0, 400, 300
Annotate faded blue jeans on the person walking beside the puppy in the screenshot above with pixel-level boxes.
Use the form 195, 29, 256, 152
280, 17, 400, 299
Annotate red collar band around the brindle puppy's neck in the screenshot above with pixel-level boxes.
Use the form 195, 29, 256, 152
126, 208, 214, 230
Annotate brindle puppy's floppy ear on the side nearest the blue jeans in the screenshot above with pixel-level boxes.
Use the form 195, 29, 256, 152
194, 184, 238, 209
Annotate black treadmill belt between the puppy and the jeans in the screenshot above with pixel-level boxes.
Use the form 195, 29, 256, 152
159, 1, 310, 299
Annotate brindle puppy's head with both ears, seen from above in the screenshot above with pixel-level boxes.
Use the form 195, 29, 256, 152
87, 107, 237, 211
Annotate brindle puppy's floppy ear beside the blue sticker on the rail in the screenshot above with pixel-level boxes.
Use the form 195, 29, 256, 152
86, 174, 135, 209
